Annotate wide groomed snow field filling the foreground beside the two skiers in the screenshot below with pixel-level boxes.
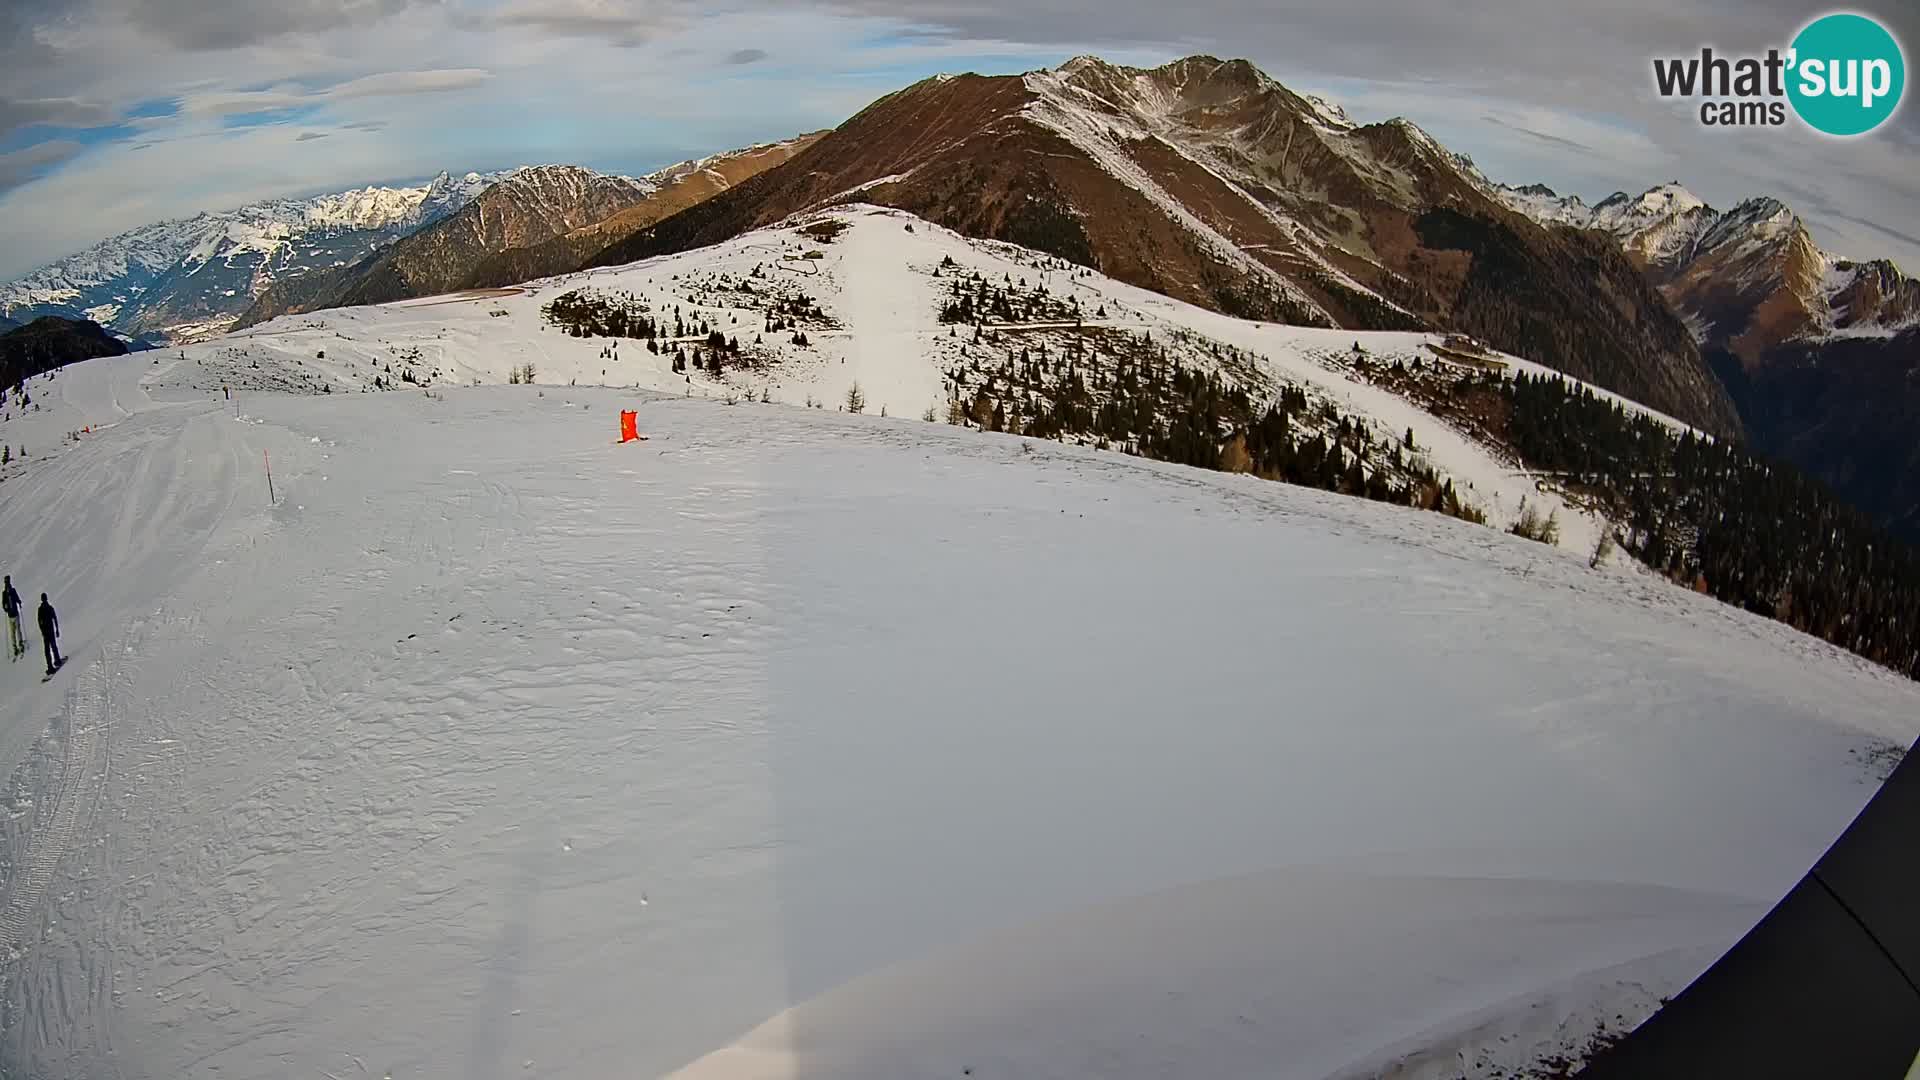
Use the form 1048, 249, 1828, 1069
0, 212, 1920, 1080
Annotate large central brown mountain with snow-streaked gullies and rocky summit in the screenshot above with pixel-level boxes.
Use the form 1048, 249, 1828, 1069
593, 58, 1740, 434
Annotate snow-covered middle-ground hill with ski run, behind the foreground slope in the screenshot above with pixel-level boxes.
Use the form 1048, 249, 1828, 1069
206, 206, 1712, 557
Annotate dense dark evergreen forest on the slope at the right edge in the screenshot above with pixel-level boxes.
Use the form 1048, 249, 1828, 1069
1453, 365, 1920, 678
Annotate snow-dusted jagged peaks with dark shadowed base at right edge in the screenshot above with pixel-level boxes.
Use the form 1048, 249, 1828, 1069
1500, 183, 1920, 540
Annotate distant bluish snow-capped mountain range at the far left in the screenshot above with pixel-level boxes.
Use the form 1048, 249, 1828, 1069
0, 173, 499, 342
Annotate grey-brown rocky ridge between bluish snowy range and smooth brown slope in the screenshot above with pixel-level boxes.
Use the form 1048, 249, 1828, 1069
236, 165, 659, 327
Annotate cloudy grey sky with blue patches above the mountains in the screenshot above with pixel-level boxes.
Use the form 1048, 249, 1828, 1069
0, 0, 1920, 279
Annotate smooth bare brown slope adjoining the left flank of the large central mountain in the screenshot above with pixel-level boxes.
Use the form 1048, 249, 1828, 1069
461, 131, 826, 288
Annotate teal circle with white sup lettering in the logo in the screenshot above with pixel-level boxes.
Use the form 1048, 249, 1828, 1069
1788, 12, 1907, 135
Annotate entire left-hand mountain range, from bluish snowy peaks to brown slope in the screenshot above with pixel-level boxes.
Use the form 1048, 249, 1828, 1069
0, 147, 810, 344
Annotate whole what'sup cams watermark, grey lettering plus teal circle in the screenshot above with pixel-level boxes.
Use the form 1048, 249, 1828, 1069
1653, 12, 1907, 136
